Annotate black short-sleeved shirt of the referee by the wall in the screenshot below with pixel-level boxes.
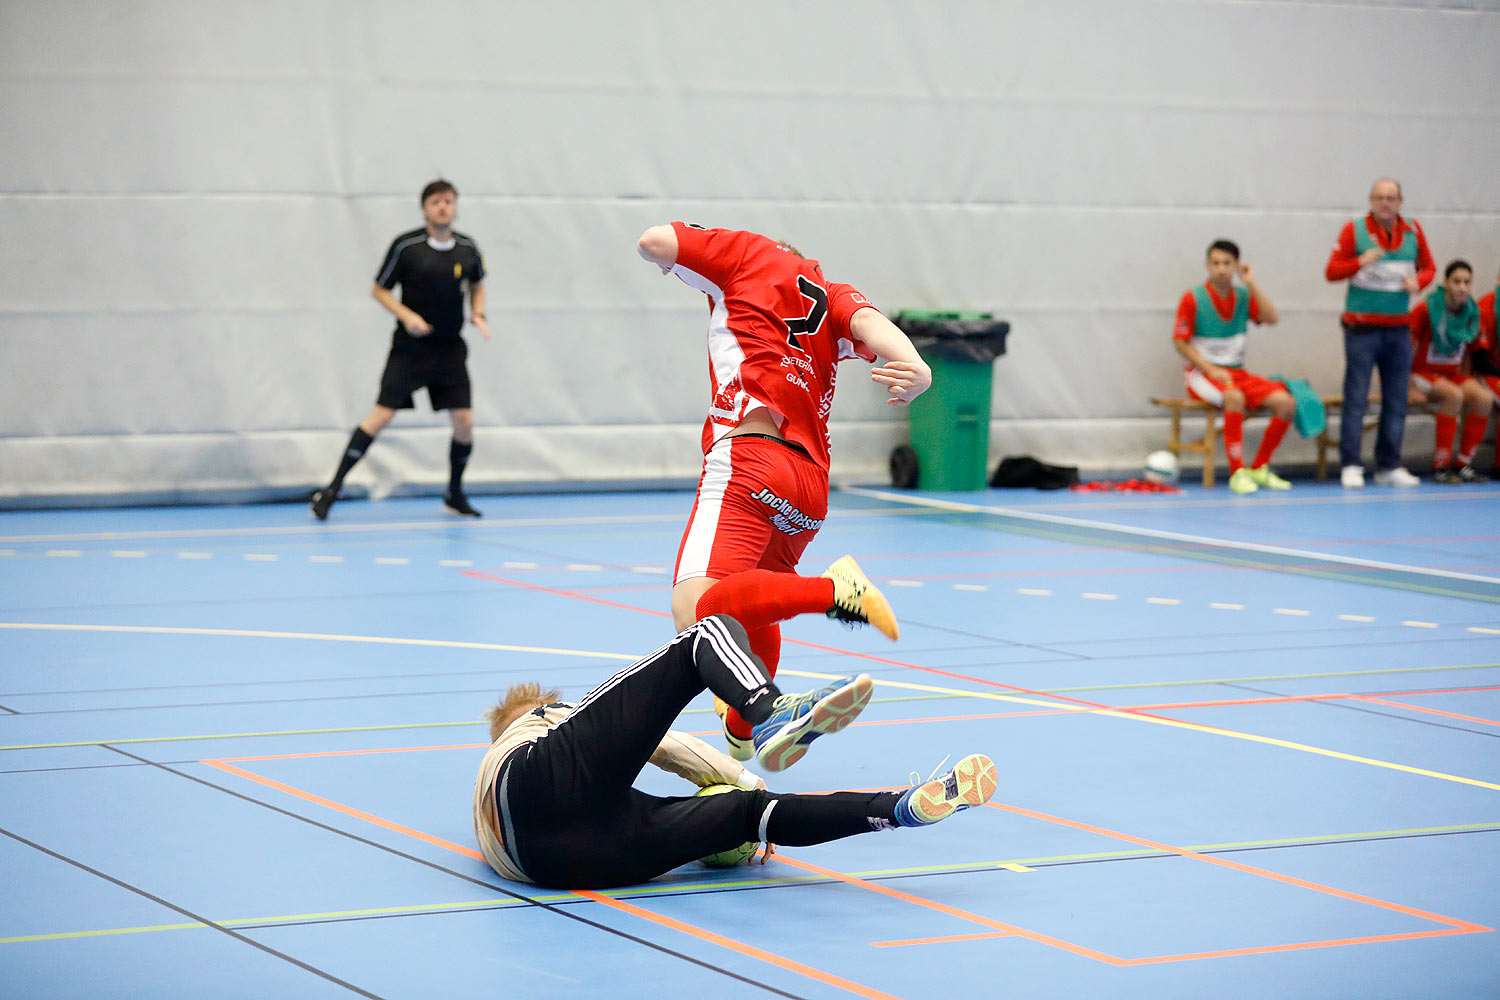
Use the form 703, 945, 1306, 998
375, 229, 485, 346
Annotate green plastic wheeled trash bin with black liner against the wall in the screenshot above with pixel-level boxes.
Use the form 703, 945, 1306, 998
891, 310, 1010, 490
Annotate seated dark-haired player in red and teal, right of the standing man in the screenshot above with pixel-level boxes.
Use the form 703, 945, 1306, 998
1409, 261, 1494, 484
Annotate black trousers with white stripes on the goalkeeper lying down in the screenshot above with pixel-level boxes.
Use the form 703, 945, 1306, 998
495, 615, 900, 889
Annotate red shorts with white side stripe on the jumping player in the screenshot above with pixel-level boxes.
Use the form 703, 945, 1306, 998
672, 435, 828, 585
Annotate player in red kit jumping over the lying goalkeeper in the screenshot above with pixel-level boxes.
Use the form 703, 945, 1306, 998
638, 222, 932, 760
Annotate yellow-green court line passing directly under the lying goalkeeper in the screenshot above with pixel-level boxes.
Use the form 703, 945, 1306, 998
0, 823, 1500, 945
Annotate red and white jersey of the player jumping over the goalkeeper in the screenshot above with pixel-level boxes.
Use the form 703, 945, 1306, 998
672, 222, 875, 471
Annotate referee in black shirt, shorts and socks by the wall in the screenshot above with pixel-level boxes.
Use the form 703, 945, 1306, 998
312, 178, 489, 520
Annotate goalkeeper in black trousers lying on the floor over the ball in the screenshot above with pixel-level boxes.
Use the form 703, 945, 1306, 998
474, 615, 996, 889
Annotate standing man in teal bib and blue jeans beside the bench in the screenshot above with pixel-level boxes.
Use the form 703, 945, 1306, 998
1325, 177, 1437, 489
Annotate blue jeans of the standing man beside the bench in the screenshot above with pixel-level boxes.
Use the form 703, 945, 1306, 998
1338, 322, 1412, 469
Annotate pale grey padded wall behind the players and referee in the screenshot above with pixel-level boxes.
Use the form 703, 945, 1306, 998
0, 0, 1500, 499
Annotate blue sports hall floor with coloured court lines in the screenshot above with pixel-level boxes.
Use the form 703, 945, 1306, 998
0, 483, 1500, 1000
